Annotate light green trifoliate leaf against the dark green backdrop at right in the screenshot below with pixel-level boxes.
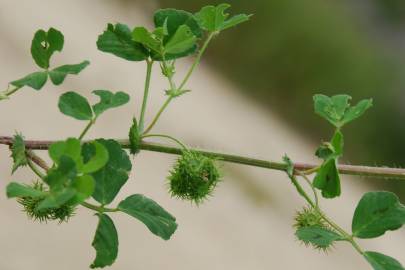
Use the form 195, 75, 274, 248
314, 95, 372, 128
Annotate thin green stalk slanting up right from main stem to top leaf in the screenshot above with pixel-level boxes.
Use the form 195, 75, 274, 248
143, 33, 216, 134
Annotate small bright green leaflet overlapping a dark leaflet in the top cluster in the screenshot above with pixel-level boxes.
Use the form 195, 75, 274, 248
165, 25, 197, 54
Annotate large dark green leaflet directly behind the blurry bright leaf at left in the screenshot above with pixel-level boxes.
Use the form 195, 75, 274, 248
82, 139, 132, 205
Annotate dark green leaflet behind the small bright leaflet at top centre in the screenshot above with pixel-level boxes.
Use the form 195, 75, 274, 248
154, 8, 202, 60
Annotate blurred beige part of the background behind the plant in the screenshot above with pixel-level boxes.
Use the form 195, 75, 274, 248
0, 0, 405, 270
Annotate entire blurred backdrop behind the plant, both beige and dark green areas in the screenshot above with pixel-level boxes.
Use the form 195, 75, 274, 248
0, 0, 405, 270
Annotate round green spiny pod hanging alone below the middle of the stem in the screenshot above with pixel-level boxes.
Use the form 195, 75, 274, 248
168, 151, 221, 204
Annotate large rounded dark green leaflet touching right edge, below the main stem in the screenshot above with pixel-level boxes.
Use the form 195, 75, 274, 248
352, 191, 405, 238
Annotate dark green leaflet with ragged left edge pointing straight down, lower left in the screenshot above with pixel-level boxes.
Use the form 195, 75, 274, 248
90, 214, 118, 268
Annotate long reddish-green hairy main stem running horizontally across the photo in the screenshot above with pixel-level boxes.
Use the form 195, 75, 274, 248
0, 136, 405, 180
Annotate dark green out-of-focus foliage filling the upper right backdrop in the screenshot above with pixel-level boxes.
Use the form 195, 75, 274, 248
159, 0, 405, 171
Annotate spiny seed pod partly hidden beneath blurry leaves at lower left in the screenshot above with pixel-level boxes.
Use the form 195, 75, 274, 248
17, 182, 75, 223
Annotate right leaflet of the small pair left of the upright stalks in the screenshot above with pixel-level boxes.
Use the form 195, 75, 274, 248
93, 90, 129, 116
